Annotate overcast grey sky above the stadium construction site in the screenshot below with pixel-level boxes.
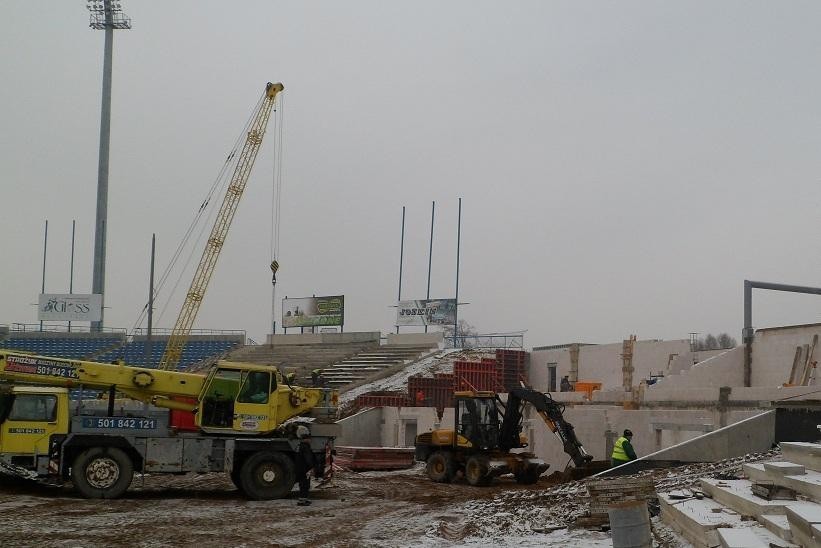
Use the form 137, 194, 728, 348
0, 0, 821, 347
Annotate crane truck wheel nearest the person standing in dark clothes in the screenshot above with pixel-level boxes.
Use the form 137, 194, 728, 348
239, 451, 296, 500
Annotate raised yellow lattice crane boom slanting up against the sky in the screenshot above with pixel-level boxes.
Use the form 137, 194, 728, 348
159, 82, 285, 369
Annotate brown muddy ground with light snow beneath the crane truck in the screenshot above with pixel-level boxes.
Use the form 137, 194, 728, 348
0, 468, 564, 547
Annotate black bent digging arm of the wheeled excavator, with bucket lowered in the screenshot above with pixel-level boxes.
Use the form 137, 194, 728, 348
499, 388, 593, 468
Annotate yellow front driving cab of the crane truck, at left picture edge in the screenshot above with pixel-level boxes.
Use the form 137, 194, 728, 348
0, 386, 70, 473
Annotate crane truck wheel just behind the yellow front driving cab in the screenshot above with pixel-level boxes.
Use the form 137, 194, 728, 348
71, 447, 134, 499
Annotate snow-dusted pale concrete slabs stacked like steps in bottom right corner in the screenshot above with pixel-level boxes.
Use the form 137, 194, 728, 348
659, 442, 821, 548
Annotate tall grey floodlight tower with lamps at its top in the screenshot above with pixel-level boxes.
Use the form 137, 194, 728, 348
86, 0, 131, 331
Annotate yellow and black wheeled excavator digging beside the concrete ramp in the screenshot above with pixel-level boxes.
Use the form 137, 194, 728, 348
415, 388, 593, 486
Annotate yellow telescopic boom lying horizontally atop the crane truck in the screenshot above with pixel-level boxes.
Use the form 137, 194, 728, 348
0, 351, 205, 410
